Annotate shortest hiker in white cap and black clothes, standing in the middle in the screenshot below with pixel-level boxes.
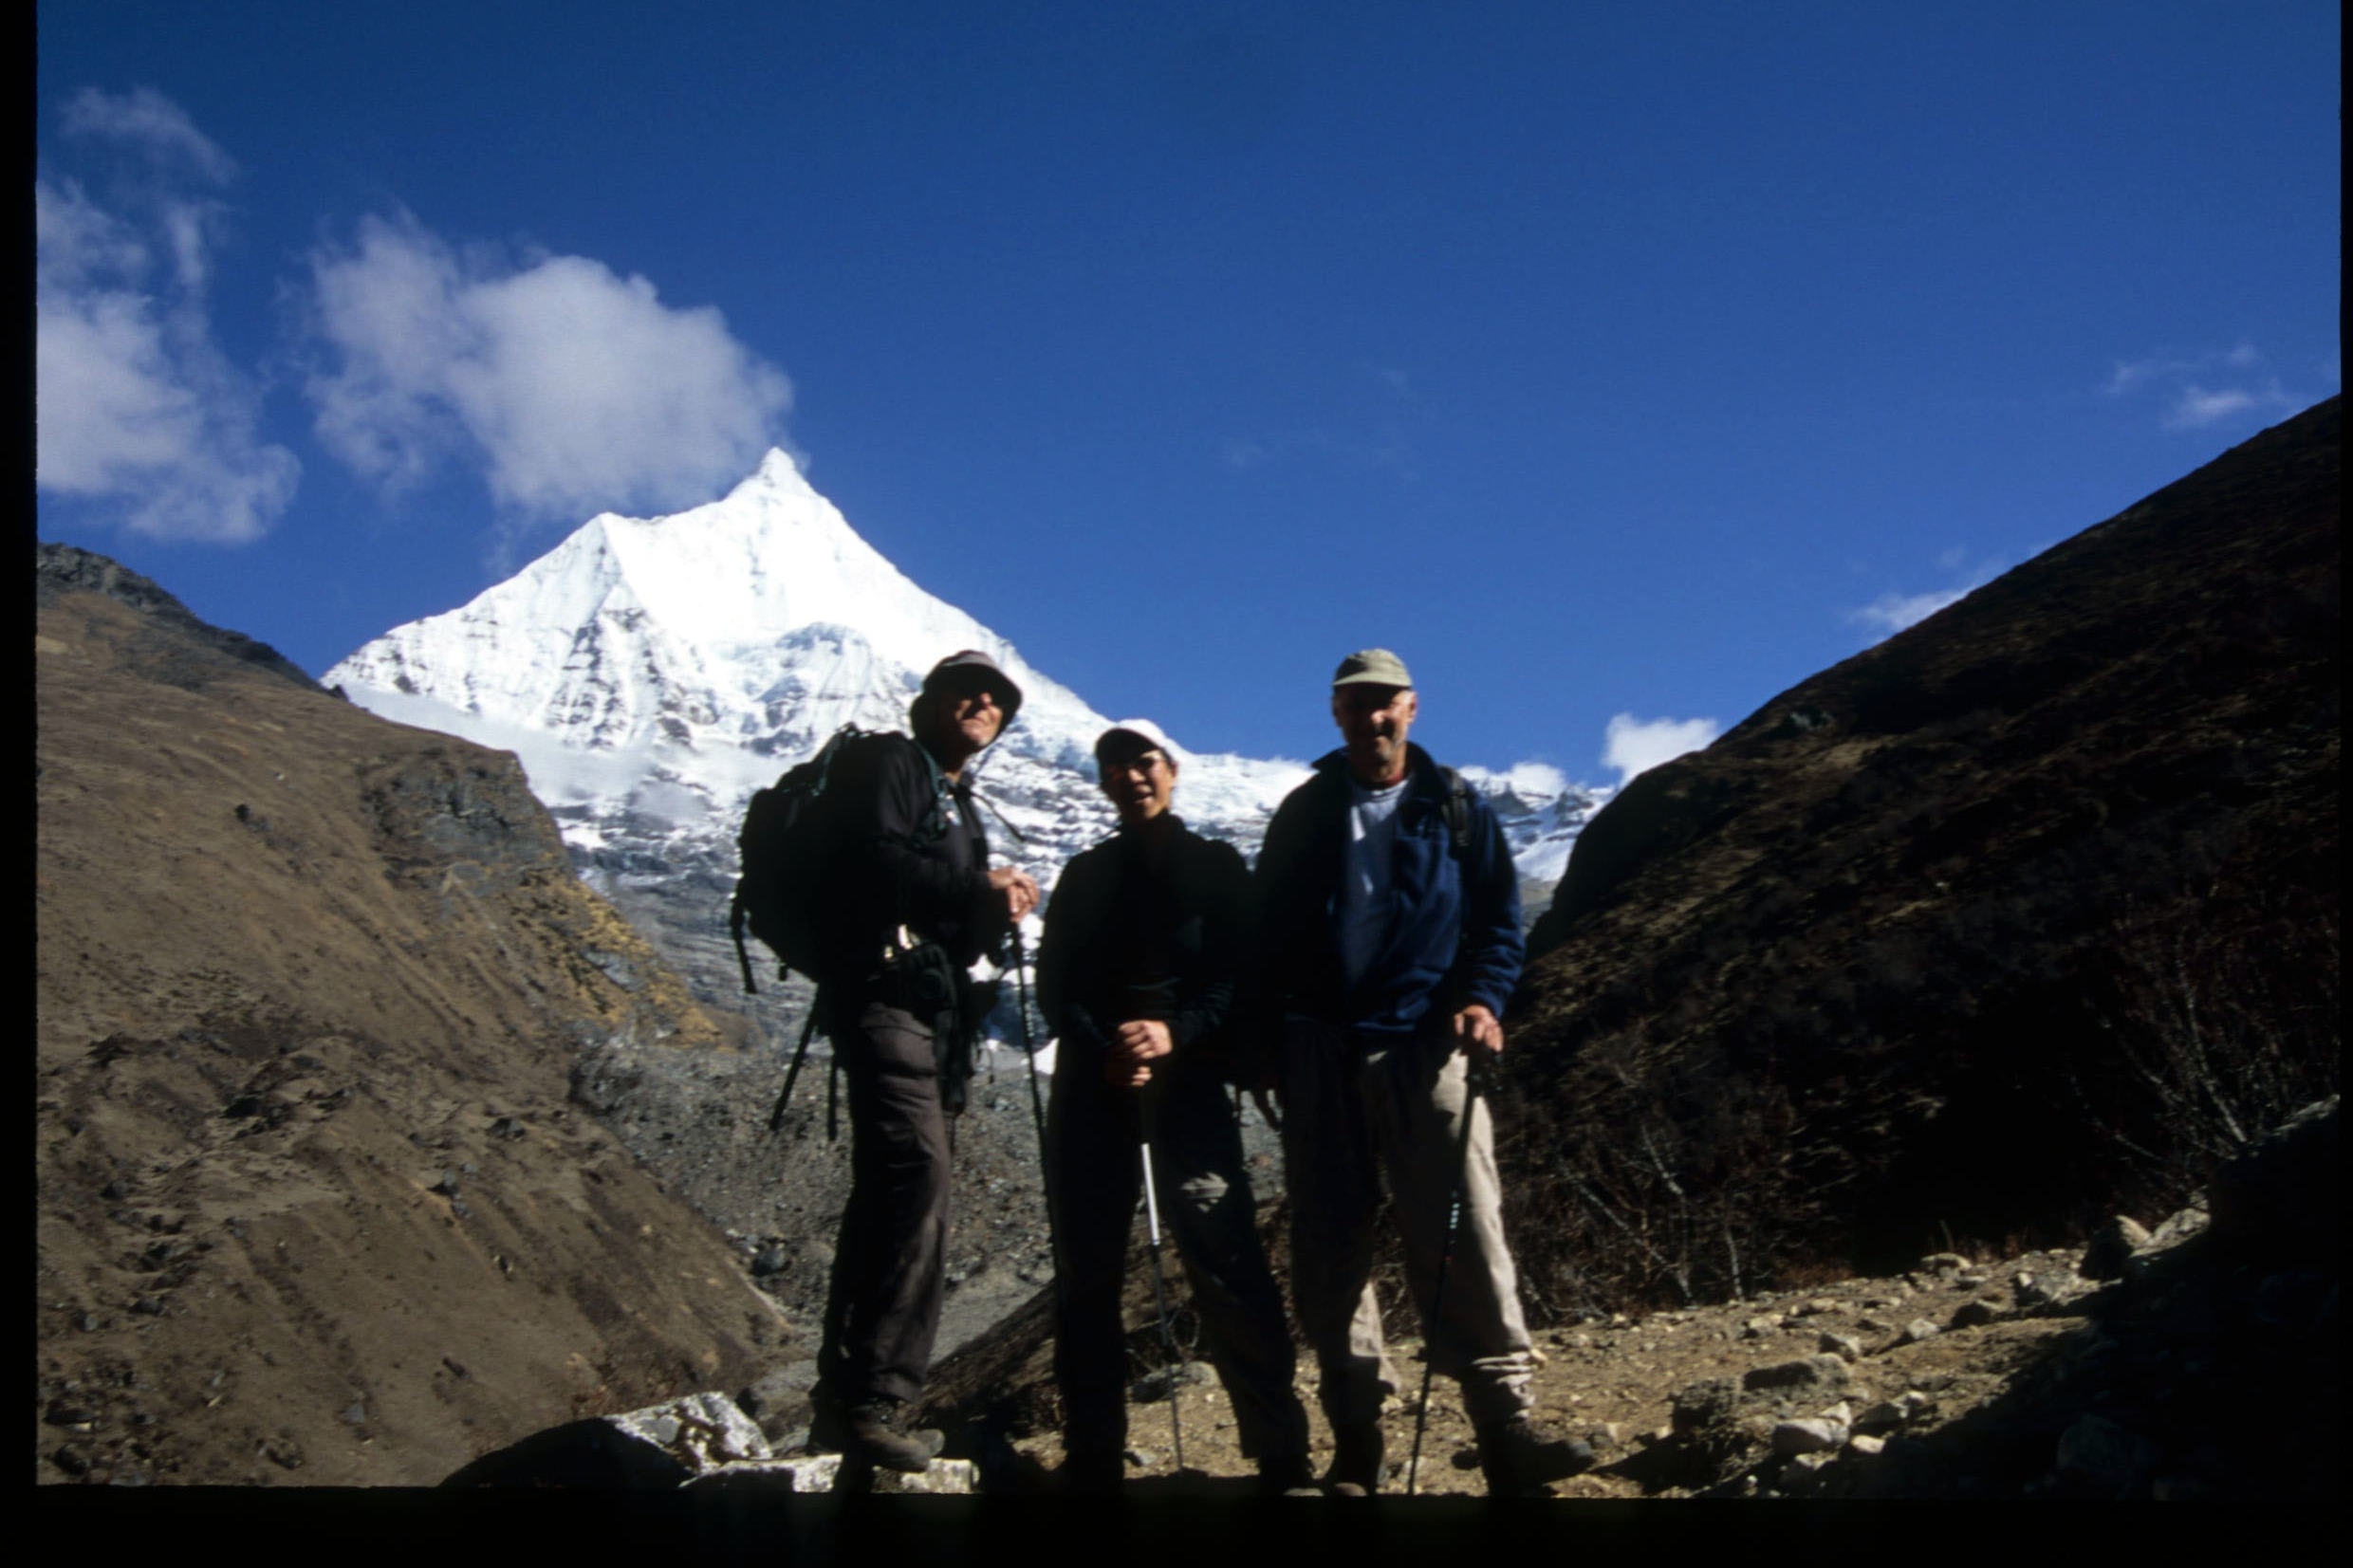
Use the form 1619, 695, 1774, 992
1038, 719, 1310, 1493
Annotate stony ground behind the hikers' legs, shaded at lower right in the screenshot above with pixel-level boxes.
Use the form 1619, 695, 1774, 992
908, 1098, 2344, 1503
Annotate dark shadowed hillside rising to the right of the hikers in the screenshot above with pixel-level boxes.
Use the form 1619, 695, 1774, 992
1504, 399, 2339, 1312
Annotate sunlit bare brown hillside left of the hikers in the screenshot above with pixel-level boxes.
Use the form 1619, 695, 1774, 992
35, 545, 788, 1484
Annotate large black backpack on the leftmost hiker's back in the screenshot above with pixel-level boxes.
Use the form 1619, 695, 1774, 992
727, 724, 932, 994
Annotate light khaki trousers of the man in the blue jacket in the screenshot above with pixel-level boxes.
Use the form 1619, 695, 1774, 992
1283, 1018, 1536, 1427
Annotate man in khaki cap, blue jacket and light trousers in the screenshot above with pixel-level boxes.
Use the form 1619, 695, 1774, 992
1250, 649, 1590, 1495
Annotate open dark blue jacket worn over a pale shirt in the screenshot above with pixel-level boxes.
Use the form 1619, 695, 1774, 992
1247, 746, 1528, 1034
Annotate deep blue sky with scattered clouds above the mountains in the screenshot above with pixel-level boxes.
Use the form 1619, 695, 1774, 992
38, 0, 2342, 783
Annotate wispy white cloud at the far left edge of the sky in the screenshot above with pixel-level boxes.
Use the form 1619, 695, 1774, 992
33, 89, 301, 543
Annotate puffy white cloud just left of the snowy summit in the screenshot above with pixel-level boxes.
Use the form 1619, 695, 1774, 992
308, 214, 793, 517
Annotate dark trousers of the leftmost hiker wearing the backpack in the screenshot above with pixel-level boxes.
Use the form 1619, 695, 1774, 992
817, 1002, 948, 1406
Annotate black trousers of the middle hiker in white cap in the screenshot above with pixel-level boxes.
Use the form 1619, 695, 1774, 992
1045, 1042, 1308, 1458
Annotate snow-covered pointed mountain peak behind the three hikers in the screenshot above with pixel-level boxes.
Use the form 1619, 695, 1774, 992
324, 452, 1598, 1010
